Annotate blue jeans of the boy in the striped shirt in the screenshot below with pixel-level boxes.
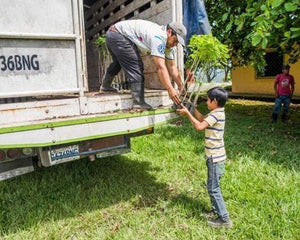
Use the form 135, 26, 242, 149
206, 158, 229, 222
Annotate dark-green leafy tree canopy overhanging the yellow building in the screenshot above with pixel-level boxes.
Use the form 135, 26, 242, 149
205, 0, 300, 71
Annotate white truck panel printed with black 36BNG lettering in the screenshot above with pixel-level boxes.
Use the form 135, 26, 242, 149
0, 39, 78, 97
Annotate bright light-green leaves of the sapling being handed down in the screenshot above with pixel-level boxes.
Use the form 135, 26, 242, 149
186, 34, 229, 82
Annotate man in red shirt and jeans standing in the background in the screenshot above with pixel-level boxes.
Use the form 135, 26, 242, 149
272, 64, 295, 123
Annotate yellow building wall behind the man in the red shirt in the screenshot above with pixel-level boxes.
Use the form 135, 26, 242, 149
232, 61, 300, 96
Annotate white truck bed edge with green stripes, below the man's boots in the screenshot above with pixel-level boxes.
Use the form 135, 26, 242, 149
0, 90, 178, 148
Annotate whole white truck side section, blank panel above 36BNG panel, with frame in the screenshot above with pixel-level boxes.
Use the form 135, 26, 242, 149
0, 0, 87, 98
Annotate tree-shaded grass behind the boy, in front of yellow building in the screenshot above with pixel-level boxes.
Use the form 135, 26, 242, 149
161, 100, 300, 171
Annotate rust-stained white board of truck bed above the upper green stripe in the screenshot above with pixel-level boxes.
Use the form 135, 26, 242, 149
0, 91, 172, 125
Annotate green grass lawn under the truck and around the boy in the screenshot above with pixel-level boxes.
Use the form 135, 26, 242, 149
0, 100, 300, 240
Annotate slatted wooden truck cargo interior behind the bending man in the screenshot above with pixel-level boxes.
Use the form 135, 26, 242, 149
84, 0, 183, 100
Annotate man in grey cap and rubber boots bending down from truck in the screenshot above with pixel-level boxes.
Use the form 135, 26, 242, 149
100, 20, 186, 109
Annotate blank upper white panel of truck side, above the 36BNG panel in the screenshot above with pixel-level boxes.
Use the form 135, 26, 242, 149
0, 0, 74, 34
